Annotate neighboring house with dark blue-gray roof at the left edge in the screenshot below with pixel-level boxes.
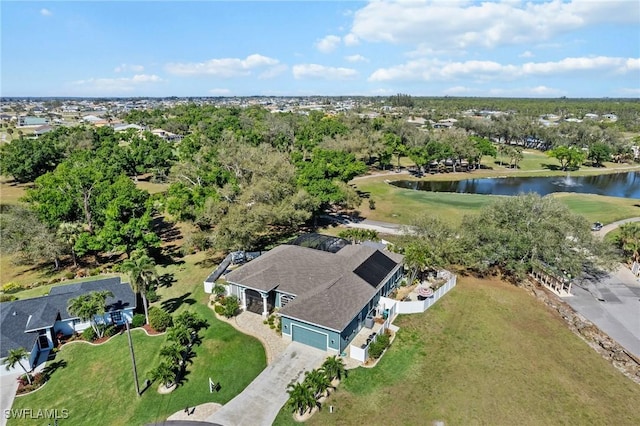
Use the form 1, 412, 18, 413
0, 277, 136, 367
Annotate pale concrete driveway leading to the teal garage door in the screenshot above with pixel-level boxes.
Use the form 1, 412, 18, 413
207, 342, 327, 426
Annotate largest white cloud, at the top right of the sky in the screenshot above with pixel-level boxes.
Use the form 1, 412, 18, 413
348, 0, 640, 49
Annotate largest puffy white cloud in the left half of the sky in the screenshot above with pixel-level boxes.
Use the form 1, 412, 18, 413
165, 54, 280, 78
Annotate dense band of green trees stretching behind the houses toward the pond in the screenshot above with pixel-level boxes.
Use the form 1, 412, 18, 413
0, 104, 629, 270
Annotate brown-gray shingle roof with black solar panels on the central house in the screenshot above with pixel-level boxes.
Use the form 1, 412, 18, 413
226, 245, 402, 331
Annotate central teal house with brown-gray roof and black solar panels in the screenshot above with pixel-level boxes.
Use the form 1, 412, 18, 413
218, 240, 403, 353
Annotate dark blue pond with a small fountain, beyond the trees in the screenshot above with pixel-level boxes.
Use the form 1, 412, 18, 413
391, 172, 640, 198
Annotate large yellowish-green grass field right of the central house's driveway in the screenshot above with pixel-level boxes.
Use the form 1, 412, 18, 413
274, 277, 640, 425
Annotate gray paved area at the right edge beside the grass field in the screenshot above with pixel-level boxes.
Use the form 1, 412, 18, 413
564, 265, 640, 358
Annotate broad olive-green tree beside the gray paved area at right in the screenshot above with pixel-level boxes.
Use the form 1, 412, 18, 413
458, 194, 615, 278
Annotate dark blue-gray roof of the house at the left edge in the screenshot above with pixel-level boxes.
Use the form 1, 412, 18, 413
0, 277, 136, 358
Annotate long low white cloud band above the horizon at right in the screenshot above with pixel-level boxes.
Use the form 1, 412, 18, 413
369, 56, 640, 81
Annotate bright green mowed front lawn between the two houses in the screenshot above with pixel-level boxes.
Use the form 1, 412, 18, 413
9, 283, 266, 425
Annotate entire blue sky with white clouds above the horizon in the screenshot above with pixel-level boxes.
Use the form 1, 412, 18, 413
0, 0, 640, 97
